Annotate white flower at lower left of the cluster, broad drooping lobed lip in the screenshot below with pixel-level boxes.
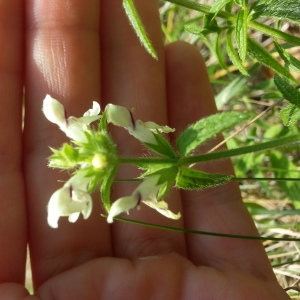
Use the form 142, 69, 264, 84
47, 173, 93, 228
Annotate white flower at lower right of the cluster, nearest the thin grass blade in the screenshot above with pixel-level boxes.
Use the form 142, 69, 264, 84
107, 175, 181, 223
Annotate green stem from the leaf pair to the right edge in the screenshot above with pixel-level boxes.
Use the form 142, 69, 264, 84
180, 134, 300, 165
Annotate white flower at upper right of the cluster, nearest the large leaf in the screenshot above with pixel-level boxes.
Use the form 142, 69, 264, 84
105, 104, 175, 145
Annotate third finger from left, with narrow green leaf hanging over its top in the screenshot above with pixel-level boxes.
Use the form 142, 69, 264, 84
101, 0, 184, 257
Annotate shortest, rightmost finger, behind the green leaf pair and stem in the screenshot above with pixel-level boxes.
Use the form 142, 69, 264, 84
166, 43, 276, 273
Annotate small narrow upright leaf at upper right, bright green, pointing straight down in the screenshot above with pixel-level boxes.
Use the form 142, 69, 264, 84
235, 8, 248, 62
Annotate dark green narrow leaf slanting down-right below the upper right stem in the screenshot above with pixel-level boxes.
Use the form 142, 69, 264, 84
248, 38, 296, 81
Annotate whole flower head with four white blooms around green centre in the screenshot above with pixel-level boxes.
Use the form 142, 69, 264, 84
42, 95, 180, 228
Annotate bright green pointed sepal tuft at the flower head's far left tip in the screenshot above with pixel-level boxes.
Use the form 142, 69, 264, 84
48, 143, 79, 169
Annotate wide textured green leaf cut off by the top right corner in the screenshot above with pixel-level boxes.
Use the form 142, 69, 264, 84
252, 0, 300, 23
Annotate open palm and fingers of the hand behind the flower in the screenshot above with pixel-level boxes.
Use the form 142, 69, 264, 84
0, 0, 289, 300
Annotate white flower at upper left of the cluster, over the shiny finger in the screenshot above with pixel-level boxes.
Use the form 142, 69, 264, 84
42, 95, 100, 143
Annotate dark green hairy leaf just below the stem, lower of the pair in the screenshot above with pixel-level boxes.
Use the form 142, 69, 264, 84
176, 167, 232, 190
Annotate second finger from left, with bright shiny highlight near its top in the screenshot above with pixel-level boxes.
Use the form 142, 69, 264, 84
25, 0, 110, 286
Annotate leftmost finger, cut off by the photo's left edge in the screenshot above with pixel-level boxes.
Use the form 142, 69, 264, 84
0, 0, 27, 283
